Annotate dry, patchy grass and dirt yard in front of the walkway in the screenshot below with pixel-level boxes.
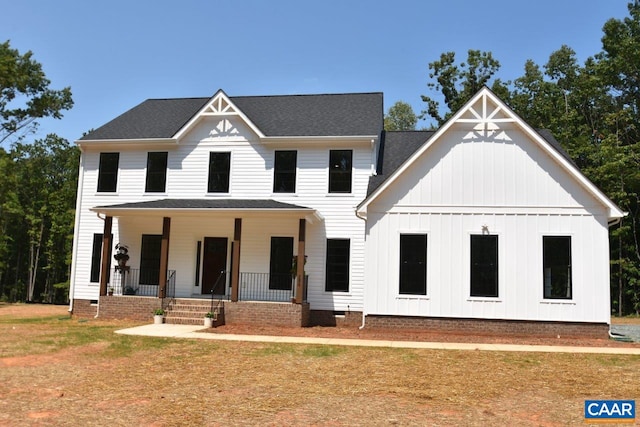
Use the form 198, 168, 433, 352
0, 304, 640, 426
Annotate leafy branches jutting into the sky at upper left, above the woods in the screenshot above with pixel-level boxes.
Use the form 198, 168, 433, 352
0, 40, 73, 144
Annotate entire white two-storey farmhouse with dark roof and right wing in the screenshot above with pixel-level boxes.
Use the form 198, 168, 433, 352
71, 89, 624, 335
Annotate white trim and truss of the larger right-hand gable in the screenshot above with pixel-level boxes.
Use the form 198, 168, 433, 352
356, 87, 626, 220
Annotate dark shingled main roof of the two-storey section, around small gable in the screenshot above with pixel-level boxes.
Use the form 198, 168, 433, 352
80, 92, 383, 141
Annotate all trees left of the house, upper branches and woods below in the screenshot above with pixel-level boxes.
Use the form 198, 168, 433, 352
0, 41, 80, 302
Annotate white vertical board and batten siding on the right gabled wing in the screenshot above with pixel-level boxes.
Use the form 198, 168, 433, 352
365, 128, 609, 322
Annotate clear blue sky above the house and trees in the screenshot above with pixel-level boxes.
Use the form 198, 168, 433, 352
0, 0, 628, 141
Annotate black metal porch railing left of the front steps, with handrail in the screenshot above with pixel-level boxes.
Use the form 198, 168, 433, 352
107, 267, 176, 297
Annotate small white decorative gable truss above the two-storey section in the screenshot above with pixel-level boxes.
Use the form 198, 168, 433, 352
174, 90, 265, 140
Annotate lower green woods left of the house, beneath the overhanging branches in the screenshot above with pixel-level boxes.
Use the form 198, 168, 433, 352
0, 135, 80, 302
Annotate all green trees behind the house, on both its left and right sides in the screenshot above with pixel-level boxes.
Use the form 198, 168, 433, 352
0, 2, 640, 314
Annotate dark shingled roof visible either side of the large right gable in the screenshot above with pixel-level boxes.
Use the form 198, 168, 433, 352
367, 129, 577, 196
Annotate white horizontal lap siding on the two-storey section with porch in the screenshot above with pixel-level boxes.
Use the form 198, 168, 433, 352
74, 117, 372, 311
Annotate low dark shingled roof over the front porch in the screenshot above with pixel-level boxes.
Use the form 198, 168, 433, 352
94, 199, 313, 211
